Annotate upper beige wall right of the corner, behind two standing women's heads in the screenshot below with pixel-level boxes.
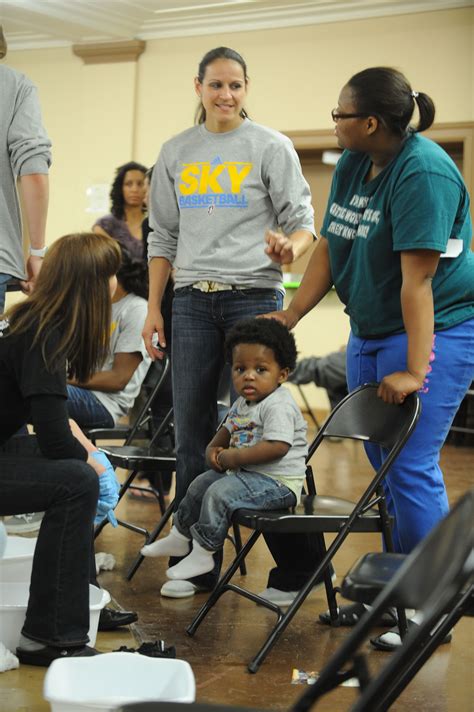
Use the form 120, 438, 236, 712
136, 9, 474, 162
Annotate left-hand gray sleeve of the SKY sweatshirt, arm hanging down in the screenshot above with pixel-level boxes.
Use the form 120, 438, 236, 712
148, 146, 179, 264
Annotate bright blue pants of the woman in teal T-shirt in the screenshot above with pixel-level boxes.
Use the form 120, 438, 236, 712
347, 319, 474, 554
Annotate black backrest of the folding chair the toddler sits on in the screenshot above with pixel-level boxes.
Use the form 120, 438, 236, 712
308, 383, 421, 459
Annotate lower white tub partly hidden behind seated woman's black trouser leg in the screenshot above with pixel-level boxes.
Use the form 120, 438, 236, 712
0, 581, 110, 653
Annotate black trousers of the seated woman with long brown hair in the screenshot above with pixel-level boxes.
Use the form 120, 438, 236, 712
0, 436, 99, 647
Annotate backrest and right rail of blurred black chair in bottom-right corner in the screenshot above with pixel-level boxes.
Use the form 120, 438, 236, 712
350, 489, 474, 712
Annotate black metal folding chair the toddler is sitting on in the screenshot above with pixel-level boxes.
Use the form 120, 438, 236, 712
187, 384, 420, 673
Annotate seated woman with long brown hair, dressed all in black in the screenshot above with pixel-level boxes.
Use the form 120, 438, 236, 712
0, 234, 120, 665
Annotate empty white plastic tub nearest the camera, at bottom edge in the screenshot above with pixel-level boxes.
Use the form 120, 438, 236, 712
43, 653, 196, 712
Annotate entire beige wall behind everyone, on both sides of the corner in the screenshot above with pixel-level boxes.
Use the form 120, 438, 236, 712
7, 8, 474, 405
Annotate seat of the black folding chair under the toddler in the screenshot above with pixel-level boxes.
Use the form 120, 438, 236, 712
233, 495, 381, 534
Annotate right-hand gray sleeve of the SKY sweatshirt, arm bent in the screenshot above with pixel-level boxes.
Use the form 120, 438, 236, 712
264, 139, 316, 235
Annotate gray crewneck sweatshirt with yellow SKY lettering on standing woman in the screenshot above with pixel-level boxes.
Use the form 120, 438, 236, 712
148, 119, 314, 288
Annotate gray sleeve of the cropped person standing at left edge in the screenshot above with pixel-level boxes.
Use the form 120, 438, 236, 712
7, 82, 51, 176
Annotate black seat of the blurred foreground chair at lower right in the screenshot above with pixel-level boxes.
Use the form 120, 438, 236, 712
341, 552, 406, 603
